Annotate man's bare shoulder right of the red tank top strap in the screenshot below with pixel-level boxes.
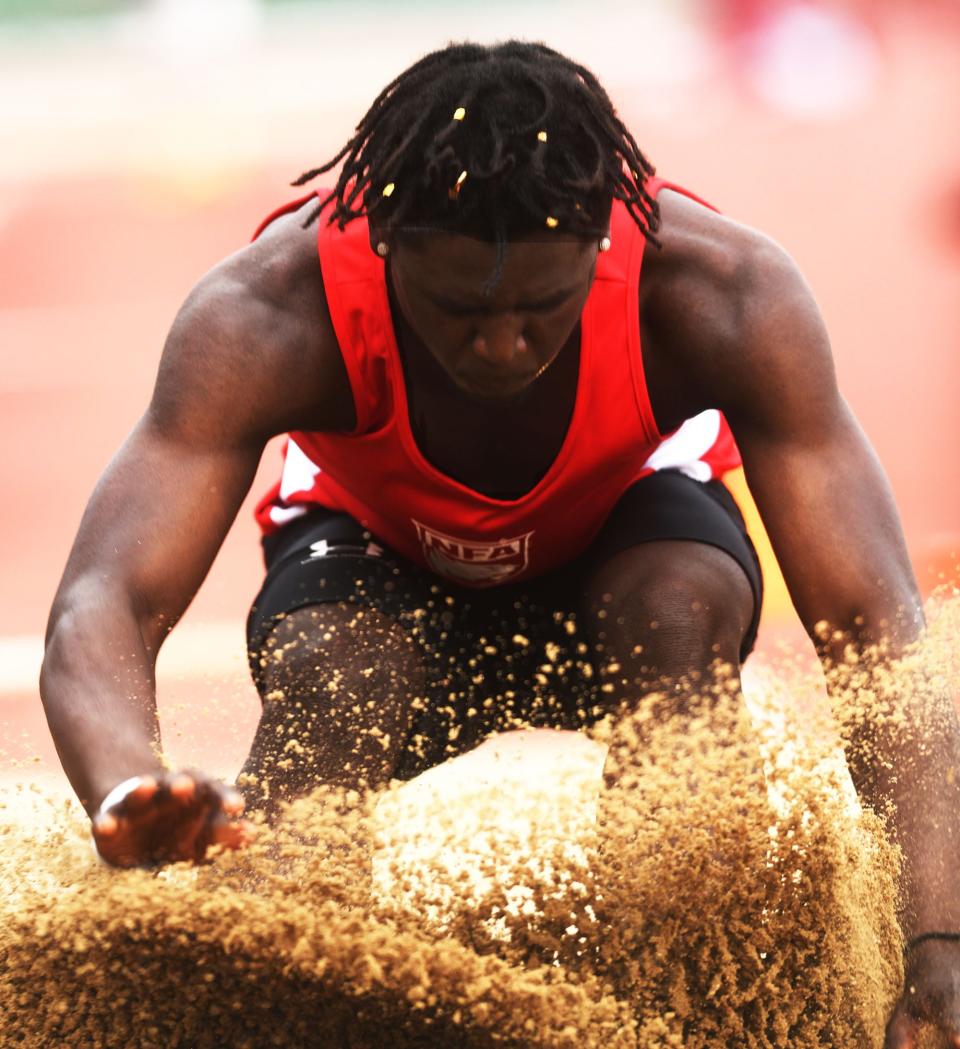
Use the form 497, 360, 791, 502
641, 191, 833, 427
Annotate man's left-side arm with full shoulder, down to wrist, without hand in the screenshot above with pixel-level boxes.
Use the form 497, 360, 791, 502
41, 217, 351, 812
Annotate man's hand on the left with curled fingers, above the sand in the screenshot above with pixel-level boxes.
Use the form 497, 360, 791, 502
92, 772, 256, 866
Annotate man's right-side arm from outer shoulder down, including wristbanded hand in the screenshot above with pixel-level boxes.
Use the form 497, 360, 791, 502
716, 238, 960, 1049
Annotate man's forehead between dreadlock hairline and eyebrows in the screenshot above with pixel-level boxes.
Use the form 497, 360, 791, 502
394, 233, 594, 298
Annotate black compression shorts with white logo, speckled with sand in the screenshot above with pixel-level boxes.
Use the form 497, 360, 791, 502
247, 470, 763, 778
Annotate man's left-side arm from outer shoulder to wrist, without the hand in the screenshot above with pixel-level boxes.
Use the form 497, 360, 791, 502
40, 288, 269, 813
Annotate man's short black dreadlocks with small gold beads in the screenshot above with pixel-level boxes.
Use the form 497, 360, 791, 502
293, 40, 660, 252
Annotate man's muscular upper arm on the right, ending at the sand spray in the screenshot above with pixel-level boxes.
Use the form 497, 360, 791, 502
728, 245, 919, 639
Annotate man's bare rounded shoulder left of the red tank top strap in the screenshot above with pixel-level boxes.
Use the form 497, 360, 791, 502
151, 200, 353, 437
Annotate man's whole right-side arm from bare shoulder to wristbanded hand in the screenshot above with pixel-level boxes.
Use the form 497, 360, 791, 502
641, 197, 960, 1049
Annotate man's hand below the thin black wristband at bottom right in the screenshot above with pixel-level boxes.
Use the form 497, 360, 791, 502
883, 940, 960, 1049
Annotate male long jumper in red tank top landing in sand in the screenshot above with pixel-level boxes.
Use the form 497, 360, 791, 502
41, 42, 960, 1049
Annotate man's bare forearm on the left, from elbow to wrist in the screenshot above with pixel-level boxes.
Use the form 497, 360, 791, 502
40, 588, 162, 813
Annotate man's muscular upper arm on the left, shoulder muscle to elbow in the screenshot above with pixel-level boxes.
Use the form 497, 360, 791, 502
51, 283, 270, 647
